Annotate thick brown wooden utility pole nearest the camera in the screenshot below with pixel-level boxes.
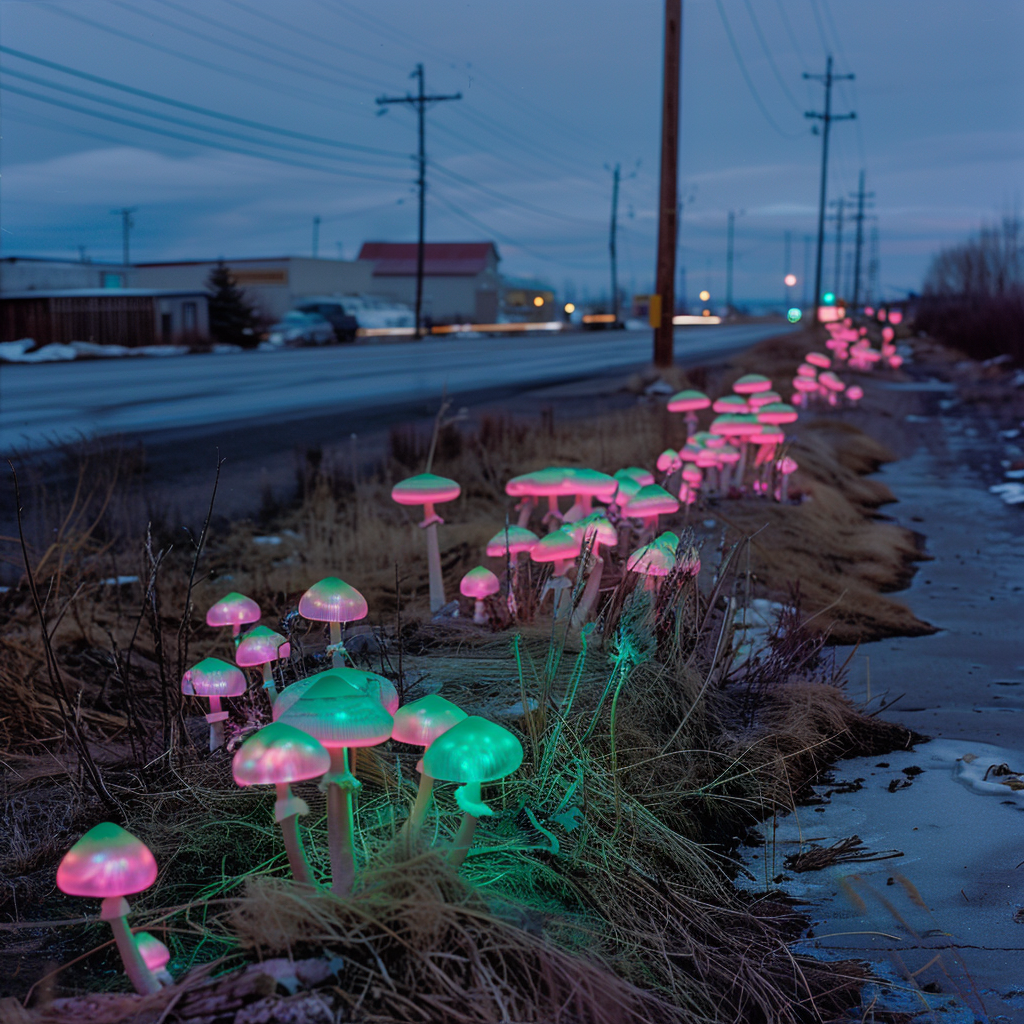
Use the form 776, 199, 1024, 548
654, 0, 683, 367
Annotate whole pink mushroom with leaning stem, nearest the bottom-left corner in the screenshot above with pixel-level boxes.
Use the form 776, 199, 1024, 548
57, 821, 160, 995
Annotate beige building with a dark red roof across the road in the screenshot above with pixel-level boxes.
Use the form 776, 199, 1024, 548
358, 242, 501, 324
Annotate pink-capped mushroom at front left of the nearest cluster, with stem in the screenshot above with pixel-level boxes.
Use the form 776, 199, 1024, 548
231, 722, 331, 885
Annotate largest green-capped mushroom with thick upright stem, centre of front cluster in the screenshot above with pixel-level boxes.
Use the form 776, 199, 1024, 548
280, 675, 393, 896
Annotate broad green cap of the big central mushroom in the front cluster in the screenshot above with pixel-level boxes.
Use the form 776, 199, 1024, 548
278, 674, 394, 749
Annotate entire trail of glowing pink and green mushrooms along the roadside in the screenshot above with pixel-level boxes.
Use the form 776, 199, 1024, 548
56, 342, 901, 993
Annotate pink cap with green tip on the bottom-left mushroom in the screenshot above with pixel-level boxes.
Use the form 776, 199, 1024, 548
57, 821, 157, 899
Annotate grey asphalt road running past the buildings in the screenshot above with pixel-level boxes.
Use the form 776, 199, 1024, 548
0, 324, 788, 453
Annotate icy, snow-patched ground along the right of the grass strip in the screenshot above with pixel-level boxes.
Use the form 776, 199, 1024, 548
743, 388, 1024, 1024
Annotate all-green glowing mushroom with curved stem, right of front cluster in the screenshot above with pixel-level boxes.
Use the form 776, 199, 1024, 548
423, 715, 522, 866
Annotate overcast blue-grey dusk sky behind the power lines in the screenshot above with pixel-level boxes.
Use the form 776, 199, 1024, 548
0, 0, 1024, 302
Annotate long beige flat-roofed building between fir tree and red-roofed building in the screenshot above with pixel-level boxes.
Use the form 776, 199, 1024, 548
131, 256, 374, 321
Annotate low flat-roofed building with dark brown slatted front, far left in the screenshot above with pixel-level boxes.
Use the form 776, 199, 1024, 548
0, 288, 210, 348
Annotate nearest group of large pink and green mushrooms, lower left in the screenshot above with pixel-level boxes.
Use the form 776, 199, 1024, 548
56, 578, 523, 994
